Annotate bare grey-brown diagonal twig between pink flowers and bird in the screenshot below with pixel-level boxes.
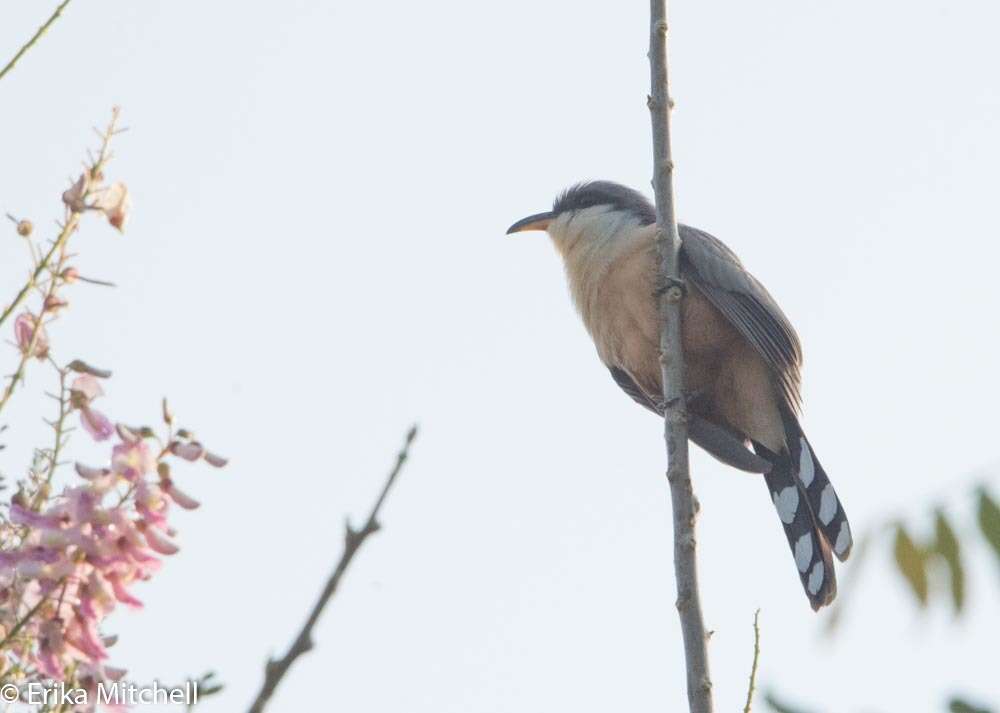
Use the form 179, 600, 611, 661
250, 426, 417, 713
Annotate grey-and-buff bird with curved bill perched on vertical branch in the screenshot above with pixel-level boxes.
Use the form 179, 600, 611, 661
507, 181, 853, 611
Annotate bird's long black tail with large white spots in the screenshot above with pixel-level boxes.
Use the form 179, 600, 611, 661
754, 413, 853, 611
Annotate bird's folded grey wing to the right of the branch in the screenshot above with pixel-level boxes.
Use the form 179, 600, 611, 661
679, 225, 802, 412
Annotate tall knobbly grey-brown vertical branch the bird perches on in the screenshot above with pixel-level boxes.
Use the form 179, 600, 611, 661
648, 0, 712, 713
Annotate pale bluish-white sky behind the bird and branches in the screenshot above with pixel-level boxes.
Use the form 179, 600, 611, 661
0, 0, 1000, 713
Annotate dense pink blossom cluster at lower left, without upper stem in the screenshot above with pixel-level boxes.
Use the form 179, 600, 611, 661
0, 374, 225, 687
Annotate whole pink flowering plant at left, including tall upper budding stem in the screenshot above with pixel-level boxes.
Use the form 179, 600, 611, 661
0, 110, 226, 710
